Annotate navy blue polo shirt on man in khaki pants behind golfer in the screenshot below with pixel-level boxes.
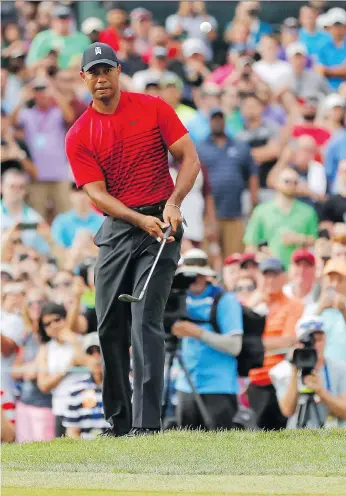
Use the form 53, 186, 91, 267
197, 136, 258, 219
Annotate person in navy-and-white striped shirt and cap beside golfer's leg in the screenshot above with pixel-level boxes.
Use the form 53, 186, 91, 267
63, 332, 109, 439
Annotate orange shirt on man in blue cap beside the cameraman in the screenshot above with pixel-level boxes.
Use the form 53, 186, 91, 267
249, 293, 304, 386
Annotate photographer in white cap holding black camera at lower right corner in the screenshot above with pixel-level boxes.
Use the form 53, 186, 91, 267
277, 317, 346, 428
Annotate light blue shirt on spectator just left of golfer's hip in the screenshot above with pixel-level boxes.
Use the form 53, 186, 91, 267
52, 210, 104, 248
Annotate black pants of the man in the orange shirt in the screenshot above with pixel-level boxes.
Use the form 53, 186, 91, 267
247, 384, 287, 431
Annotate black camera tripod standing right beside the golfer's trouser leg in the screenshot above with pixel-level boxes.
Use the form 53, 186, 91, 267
162, 335, 213, 430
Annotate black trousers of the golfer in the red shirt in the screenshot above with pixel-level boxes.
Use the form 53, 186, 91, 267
95, 217, 182, 434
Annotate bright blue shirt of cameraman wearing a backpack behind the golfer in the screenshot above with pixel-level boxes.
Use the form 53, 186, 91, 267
176, 285, 243, 394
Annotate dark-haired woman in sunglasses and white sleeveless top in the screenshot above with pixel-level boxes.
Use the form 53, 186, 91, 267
37, 302, 87, 437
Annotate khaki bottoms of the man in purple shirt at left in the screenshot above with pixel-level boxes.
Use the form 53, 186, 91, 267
28, 181, 71, 218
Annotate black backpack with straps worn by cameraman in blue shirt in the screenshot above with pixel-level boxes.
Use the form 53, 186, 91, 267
193, 288, 266, 377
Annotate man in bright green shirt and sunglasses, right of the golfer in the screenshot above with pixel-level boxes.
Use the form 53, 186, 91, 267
244, 168, 318, 268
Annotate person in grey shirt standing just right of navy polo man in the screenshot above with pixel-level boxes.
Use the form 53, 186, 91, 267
238, 93, 280, 196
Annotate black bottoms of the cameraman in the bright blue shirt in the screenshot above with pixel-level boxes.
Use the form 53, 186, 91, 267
177, 392, 238, 429
